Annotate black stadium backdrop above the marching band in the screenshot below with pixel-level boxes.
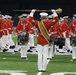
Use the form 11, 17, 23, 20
0, 0, 76, 25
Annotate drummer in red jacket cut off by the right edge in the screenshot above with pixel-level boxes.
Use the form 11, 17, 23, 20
69, 14, 76, 60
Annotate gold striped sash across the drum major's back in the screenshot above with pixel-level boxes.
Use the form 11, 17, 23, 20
38, 21, 49, 43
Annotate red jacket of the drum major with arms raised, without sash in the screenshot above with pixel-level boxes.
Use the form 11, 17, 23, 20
29, 17, 58, 45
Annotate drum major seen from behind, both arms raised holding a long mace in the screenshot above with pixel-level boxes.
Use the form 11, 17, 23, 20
27, 10, 58, 72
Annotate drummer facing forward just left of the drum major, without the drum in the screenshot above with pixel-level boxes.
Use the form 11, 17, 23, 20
16, 14, 32, 58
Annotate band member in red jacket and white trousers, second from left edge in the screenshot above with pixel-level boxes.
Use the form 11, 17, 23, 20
1, 16, 9, 52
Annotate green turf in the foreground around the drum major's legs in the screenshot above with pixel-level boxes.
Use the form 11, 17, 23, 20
0, 52, 76, 75
